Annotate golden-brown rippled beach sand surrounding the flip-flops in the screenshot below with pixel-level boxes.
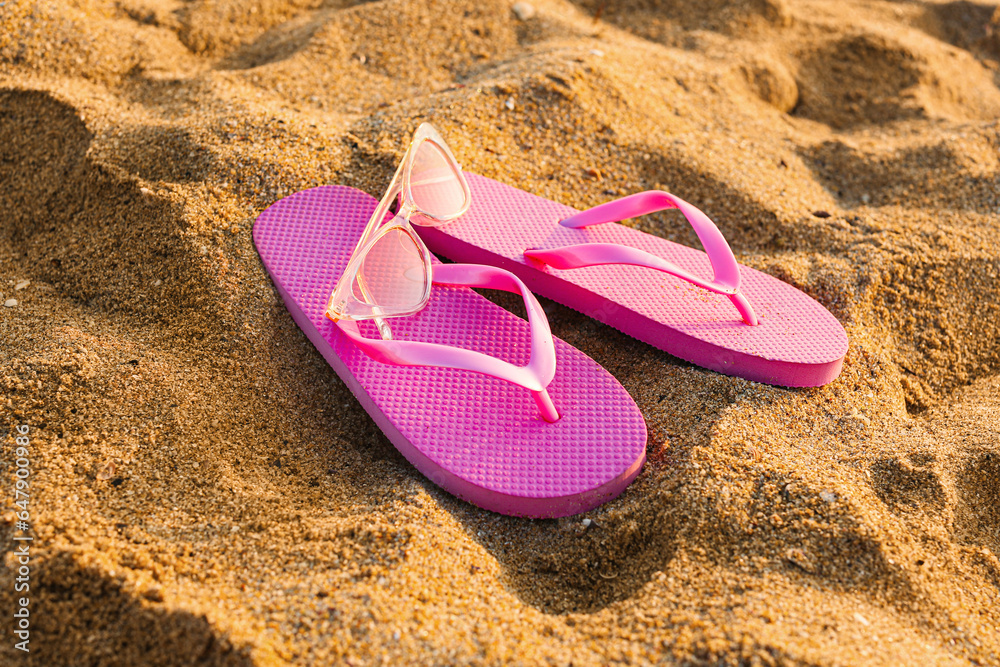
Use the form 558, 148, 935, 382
0, 0, 1000, 666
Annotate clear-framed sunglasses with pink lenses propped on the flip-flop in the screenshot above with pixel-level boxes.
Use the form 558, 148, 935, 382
326, 123, 471, 340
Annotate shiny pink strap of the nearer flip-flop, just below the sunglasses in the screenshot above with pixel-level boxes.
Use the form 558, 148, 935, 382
337, 264, 559, 422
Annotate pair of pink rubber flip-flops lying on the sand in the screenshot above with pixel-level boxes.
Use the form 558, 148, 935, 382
253, 126, 847, 518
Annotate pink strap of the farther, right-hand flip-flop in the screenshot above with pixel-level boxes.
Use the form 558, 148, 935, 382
524, 190, 758, 326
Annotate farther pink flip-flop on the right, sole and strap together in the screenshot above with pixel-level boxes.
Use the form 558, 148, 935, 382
417, 173, 847, 387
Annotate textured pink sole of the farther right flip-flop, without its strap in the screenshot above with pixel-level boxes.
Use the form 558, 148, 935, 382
417, 174, 847, 387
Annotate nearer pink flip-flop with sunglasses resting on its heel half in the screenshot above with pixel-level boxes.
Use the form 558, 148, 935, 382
253, 186, 646, 517
